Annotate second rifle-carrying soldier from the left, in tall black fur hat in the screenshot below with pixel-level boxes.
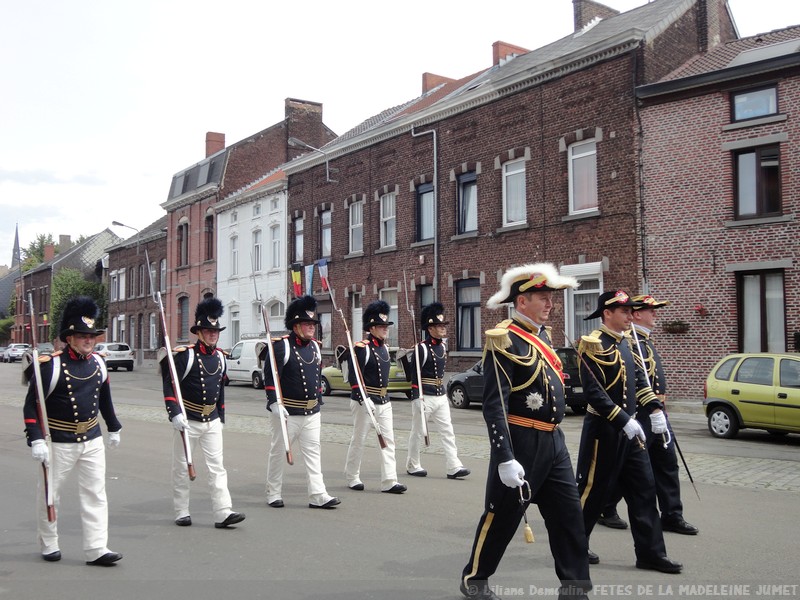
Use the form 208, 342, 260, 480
161, 298, 244, 529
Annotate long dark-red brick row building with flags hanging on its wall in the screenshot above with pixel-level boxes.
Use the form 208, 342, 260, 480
284, 0, 737, 370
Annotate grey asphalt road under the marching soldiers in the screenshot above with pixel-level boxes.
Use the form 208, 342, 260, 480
0, 365, 800, 600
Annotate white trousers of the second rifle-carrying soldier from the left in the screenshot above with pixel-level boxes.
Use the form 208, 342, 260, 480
172, 419, 233, 523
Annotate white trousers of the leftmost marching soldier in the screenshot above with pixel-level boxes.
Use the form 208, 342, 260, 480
36, 436, 109, 561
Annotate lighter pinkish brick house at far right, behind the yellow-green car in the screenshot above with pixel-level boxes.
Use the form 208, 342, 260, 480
637, 27, 800, 398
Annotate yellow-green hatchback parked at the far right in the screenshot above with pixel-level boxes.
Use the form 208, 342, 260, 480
703, 352, 800, 438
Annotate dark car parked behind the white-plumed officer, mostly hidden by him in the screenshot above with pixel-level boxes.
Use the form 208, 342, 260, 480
447, 348, 586, 415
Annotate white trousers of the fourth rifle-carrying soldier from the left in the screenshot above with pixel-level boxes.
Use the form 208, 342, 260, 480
344, 400, 397, 490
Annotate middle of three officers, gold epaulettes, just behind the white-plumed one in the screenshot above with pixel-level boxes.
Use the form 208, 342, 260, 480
577, 290, 683, 573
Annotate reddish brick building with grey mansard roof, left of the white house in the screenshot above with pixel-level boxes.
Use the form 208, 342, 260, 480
161, 98, 335, 342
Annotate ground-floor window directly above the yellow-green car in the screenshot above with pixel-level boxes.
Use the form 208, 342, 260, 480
737, 271, 786, 352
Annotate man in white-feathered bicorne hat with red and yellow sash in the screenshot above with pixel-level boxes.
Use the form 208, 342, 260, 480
461, 263, 592, 600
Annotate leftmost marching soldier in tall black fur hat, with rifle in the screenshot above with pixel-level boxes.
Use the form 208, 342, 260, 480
24, 296, 122, 567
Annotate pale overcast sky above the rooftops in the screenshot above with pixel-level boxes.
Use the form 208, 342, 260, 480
0, 0, 800, 265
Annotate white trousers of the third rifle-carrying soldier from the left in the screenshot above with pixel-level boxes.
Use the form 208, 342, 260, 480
267, 404, 331, 506
